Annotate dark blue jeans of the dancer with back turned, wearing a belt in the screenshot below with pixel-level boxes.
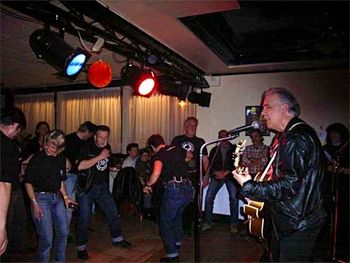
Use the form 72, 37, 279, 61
159, 182, 194, 257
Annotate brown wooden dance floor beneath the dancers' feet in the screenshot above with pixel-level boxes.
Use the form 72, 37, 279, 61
7, 214, 330, 262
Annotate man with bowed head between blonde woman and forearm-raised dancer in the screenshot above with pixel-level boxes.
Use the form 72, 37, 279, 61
64, 121, 96, 240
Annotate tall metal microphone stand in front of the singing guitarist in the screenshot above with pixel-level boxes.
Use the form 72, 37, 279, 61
194, 132, 239, 262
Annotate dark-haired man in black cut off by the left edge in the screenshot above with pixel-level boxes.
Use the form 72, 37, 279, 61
0, 107, 26, 255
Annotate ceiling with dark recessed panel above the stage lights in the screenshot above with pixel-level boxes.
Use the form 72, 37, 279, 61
1, 0, 349, 92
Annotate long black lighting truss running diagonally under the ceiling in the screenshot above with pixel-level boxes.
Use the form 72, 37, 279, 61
2, 1, 209, 88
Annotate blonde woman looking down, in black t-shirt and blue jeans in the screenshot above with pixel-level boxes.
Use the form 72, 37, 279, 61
24, 130, 76, 262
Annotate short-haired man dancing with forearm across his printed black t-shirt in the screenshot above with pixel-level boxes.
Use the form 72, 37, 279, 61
77, 125, 131, 260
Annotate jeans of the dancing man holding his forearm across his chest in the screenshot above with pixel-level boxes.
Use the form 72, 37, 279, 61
77, 183, 123, 250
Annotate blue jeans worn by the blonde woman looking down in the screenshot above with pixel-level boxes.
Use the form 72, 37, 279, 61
32, 192, 68, 262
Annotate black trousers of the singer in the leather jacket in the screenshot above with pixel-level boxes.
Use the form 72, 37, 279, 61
271, 221, 324, 262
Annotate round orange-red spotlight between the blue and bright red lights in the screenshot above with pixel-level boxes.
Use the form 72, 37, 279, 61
88, 60, 112, 88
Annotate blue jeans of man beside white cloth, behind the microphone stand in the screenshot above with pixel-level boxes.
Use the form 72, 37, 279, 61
204, 178, 238, 225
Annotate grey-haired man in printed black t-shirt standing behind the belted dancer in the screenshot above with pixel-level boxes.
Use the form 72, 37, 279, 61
171, 117, 209, 234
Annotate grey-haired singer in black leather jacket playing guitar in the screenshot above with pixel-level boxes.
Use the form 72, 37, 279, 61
233, 88, 326, 262
